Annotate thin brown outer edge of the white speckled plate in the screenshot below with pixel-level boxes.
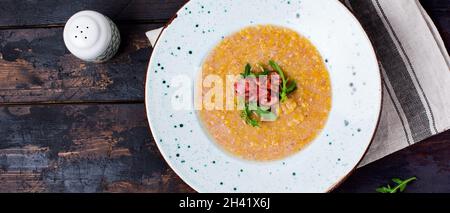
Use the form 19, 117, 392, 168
144, 0, 384, 192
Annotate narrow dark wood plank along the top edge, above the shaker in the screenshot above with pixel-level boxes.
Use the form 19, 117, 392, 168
0, 0, 186, 27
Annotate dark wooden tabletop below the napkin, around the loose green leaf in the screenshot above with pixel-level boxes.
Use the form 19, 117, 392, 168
336, 131, 450, 193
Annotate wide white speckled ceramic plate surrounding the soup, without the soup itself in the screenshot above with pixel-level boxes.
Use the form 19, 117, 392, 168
146, 0, 381, 192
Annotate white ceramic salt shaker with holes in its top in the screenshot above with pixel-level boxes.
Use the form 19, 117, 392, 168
64, 10, 120, 63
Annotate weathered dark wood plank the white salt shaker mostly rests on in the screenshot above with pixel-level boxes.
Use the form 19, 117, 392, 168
0, 24, 161, 103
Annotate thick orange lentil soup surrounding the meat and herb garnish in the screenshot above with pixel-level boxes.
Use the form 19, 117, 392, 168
199, 25, 332, 161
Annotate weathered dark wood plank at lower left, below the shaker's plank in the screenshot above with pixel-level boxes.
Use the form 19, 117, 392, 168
0, 104, 192, 192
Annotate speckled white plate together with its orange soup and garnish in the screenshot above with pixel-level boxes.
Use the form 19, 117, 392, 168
146, 0, 381, 192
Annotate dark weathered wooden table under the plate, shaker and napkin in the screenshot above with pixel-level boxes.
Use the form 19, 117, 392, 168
0, 0, 450, 192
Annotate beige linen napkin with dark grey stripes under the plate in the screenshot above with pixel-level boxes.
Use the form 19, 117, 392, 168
146, 0, 450, 167
